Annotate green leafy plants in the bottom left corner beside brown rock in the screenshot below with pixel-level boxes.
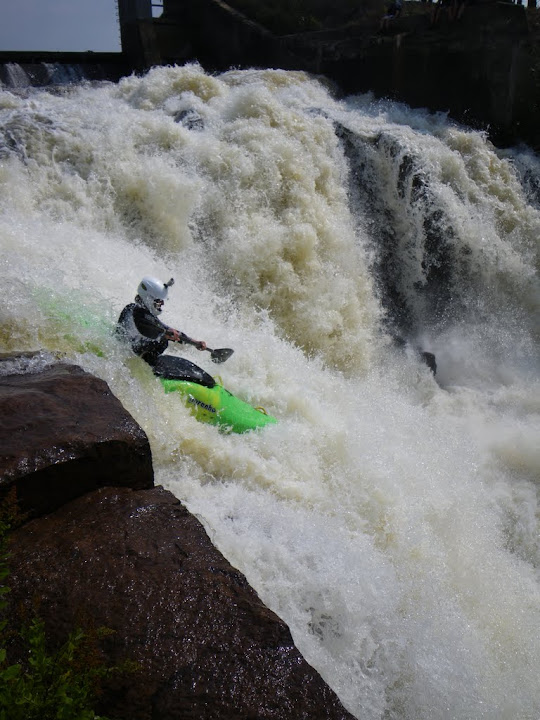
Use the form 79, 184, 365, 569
0, 510, 132, 720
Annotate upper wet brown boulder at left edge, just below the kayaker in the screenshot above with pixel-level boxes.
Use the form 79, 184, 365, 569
0, 359, 154, 517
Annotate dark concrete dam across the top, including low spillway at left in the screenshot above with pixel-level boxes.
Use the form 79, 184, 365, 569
0, 0, 540, 151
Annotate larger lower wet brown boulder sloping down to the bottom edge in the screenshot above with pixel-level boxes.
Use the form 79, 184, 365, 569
6, 487, 352, 720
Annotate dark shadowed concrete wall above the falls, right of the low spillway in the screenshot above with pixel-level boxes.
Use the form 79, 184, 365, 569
148, 0, 540, 149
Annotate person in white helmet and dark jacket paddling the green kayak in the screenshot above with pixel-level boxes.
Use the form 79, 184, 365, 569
116, 276, 210, 375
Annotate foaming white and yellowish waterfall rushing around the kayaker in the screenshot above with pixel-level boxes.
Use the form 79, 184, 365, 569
0, 65, 540, 720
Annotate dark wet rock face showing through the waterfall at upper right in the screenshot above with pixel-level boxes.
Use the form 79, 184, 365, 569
334, 123, 456, 337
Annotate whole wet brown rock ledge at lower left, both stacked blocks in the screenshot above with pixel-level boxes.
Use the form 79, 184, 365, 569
0, 363, 352, 720
